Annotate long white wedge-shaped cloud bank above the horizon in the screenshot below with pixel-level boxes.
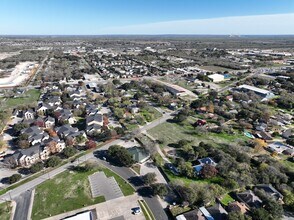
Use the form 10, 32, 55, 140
99, 13, 294, 35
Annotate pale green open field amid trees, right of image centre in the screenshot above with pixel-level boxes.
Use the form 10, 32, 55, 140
148, 119, 246, 146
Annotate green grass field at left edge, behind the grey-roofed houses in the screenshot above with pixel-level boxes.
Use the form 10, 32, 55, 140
1, 89, 40, 108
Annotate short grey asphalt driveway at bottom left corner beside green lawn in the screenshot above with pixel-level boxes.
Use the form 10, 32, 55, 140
13, 190, 32, 220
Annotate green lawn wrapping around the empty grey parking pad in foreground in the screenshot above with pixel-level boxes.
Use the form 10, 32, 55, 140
32, 164, 134, 220
